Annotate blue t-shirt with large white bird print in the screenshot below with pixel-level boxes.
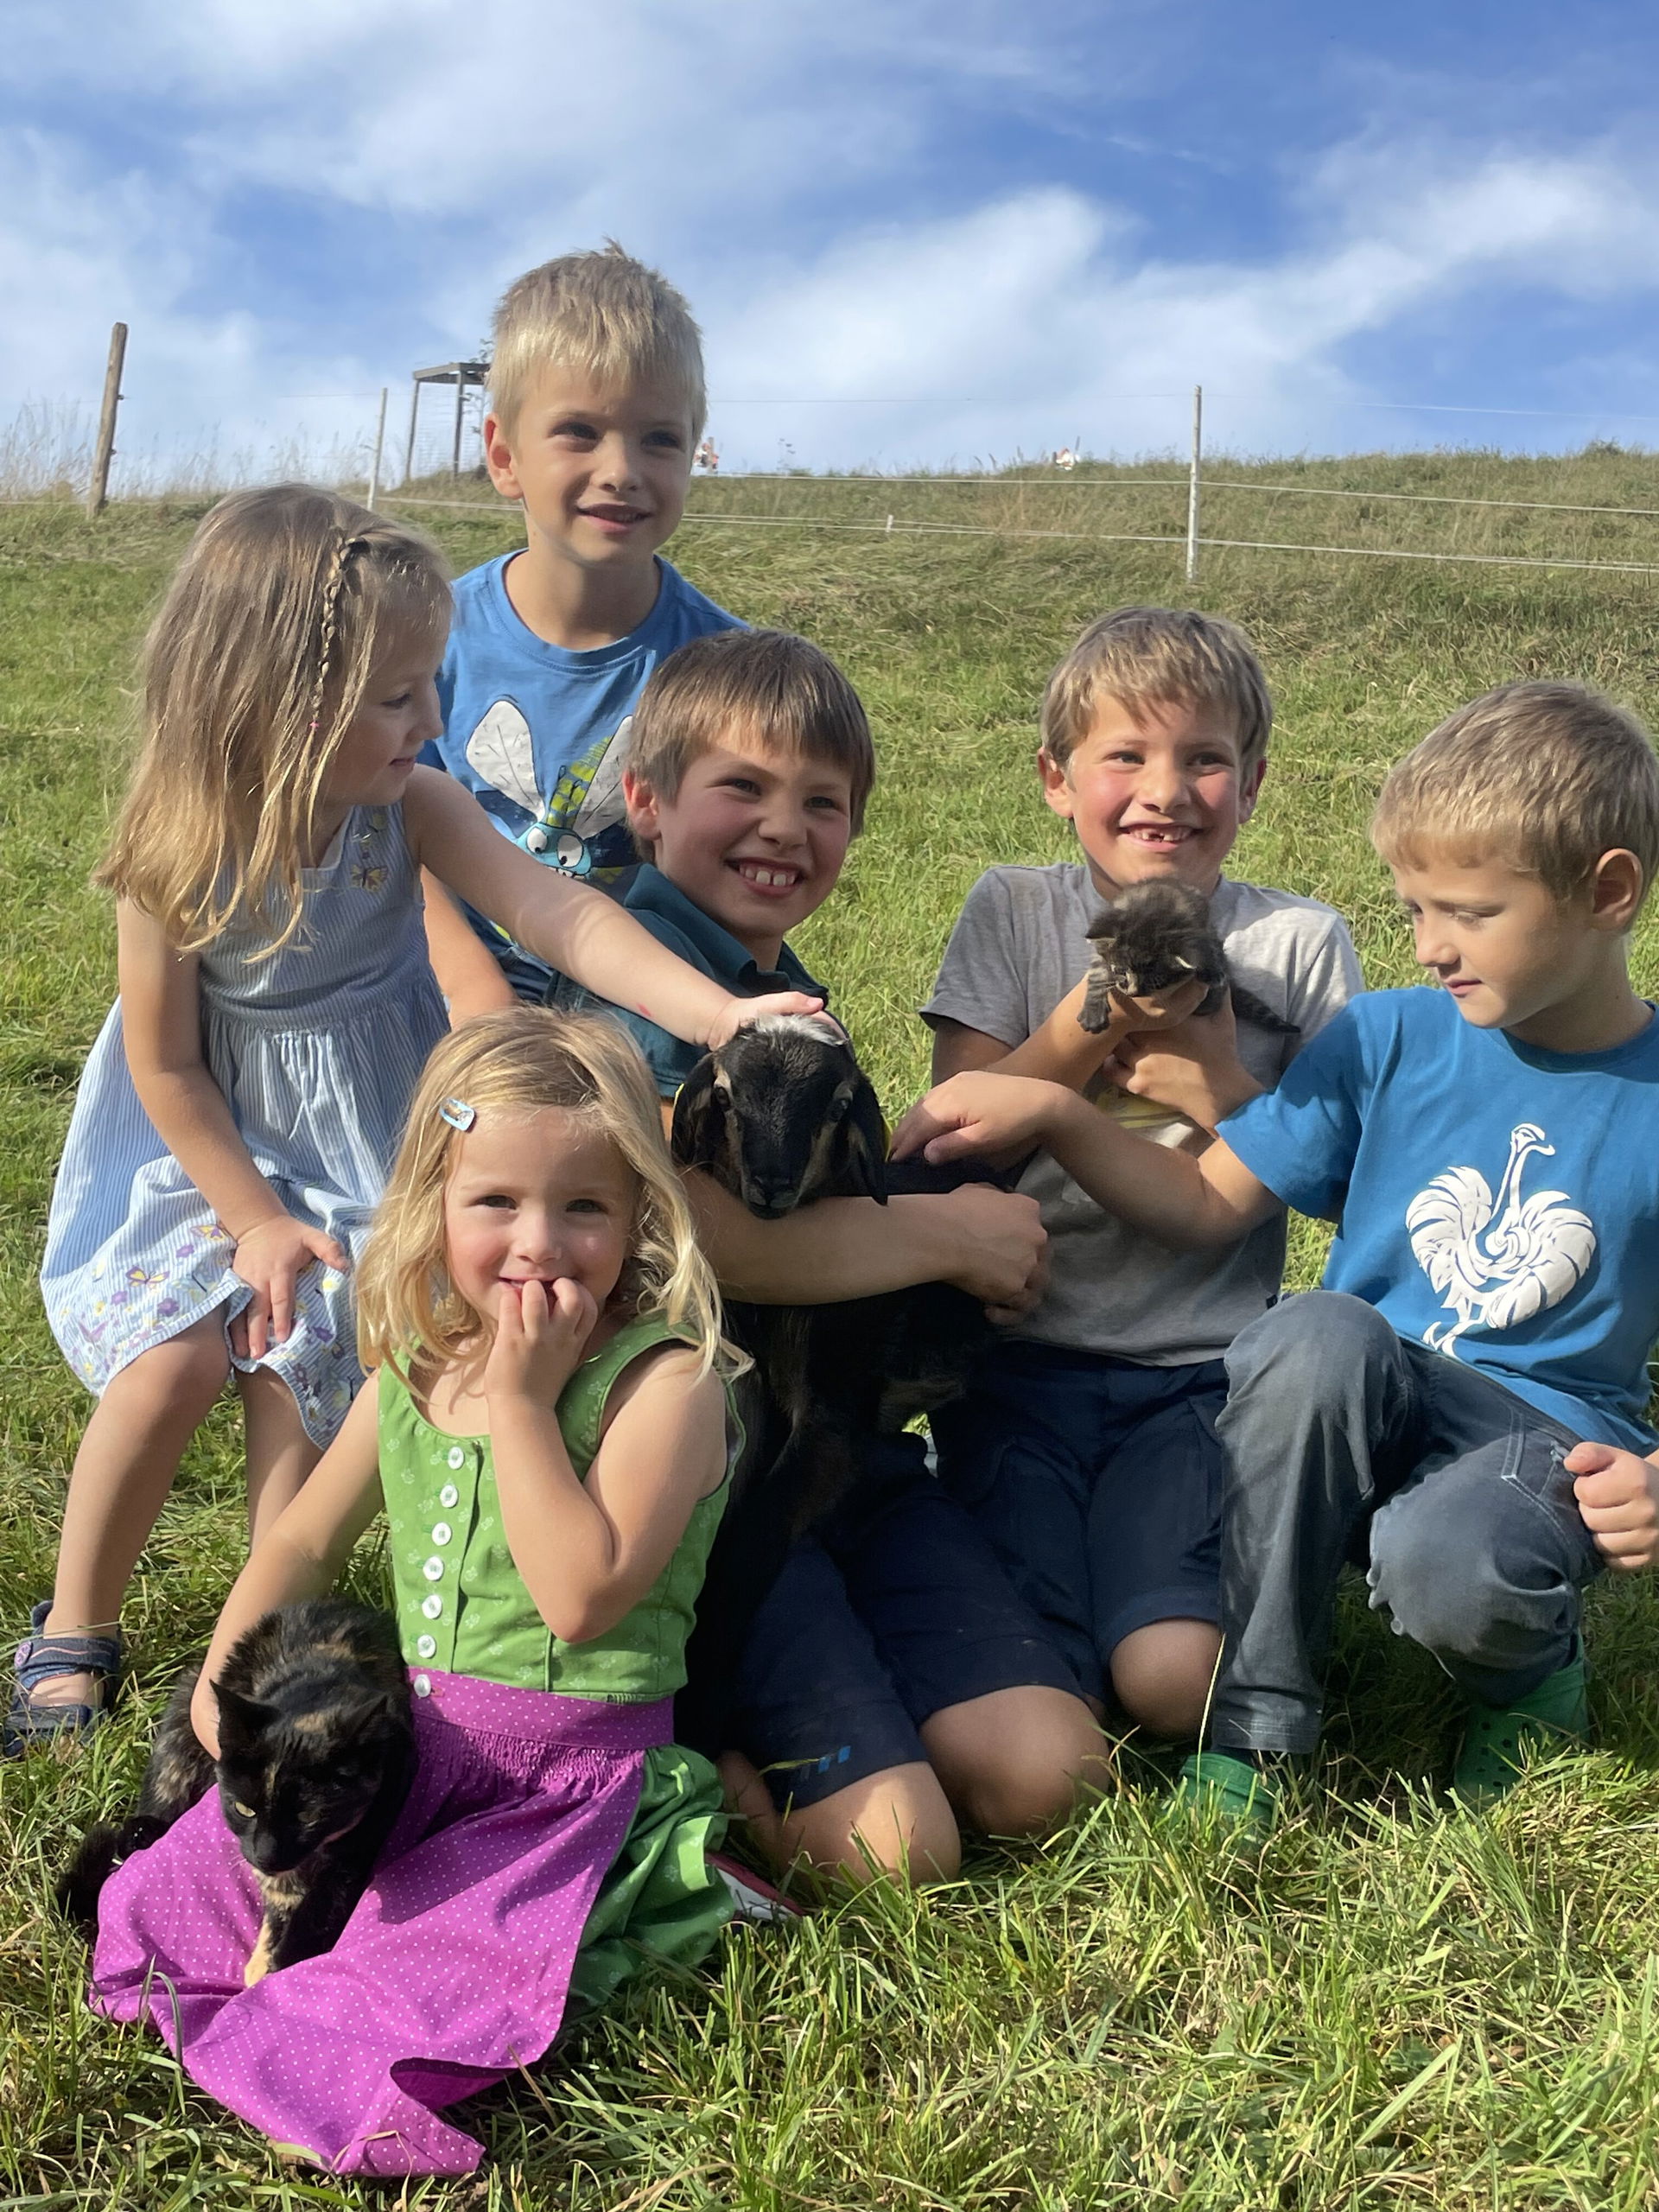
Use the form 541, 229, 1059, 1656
1221, 988, 1659, 1453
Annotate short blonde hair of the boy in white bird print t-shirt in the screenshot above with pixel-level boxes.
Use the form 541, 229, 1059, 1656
1371, 683, 1659, 900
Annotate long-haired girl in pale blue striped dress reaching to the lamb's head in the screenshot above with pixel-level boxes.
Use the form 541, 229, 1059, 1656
7, 485, 812, 1750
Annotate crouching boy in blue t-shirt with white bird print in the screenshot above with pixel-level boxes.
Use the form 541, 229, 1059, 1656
911, 683, 1659, 1825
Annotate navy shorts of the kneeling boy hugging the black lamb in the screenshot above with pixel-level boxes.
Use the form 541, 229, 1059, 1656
728, 1435, 1077, 1812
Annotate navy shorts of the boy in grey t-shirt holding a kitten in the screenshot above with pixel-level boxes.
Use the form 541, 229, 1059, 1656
933, 1340, 1228, 1699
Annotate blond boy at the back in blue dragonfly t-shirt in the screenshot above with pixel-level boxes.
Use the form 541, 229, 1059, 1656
425, 245, 741, 1018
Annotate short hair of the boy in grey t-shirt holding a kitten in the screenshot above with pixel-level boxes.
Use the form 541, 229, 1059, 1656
1042, 606, 1274, 777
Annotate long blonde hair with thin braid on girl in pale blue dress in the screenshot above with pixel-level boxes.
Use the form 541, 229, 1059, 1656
93, 485, 449, 951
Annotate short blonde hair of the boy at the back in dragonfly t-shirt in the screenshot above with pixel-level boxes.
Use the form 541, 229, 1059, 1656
489, 238, 708, 442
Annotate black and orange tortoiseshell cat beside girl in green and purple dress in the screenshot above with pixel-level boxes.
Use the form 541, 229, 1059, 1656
58, 1597, 414, 1986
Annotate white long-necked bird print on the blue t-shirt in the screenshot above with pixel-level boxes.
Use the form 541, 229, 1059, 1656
1405, 1122, 1595, 1360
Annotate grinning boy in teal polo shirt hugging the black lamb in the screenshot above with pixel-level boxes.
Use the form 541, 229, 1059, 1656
553, 631, 1119, 1880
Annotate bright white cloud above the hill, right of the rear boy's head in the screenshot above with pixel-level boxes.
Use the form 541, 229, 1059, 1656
710, 155, 1659, 465
